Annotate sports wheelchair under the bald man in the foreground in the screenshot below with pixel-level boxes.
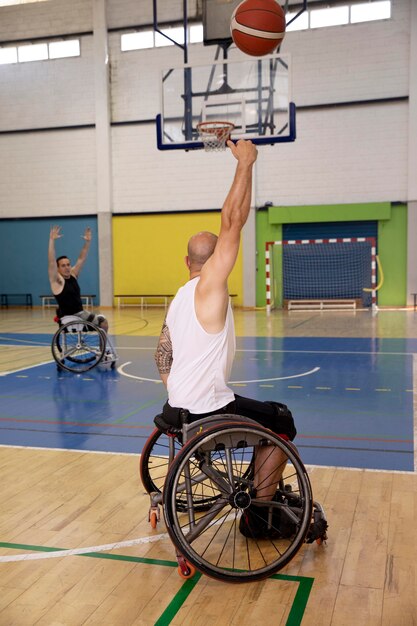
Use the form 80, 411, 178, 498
140, 411, 328, 582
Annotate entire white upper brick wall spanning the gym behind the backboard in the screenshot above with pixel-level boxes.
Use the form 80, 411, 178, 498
0, 0, 411, 217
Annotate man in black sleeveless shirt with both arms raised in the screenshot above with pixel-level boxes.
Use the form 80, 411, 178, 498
48, 226, 114, 357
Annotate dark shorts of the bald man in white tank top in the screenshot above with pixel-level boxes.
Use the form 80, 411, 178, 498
162, 394, 297, 441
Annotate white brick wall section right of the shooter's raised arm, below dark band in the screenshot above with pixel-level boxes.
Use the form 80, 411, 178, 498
256, 103, 408, 206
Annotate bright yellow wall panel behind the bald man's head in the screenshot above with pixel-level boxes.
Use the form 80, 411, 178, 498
113, 211, 243, 304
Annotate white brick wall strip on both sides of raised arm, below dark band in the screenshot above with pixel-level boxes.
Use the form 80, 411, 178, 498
113, 103, 407, 213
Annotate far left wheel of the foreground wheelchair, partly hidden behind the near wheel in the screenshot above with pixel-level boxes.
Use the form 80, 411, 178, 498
140, 428, 228, 511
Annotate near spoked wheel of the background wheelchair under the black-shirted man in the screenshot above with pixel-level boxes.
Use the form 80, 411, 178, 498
52, 321, 106, 374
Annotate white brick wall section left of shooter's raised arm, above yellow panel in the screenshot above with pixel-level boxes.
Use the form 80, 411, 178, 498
112, 126, 235, 213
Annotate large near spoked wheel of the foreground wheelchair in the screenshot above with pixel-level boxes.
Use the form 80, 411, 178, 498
164, 422, 312, 582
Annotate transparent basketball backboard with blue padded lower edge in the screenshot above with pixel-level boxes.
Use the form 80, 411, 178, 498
156, 54, 296, 150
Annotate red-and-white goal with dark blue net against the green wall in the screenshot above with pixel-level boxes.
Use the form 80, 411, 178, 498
265, 237, 377, 313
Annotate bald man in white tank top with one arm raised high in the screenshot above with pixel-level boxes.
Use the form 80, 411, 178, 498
155, 140, 296, 536
